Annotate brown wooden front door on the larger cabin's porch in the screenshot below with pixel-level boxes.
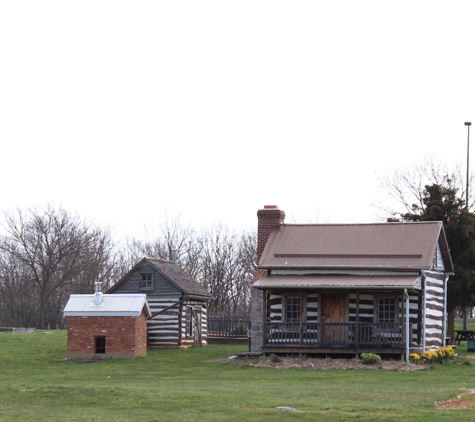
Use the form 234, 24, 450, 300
321, 293, 346, 345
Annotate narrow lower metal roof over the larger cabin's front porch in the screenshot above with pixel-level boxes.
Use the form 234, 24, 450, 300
253, 274, 421, 290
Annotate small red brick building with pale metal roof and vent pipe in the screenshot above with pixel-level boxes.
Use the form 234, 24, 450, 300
63, 292, 151, 359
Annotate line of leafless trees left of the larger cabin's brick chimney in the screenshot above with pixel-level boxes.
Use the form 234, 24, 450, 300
0, 205, 256, 328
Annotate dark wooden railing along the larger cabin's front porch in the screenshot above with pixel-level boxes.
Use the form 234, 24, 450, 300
265, 322, 412, 347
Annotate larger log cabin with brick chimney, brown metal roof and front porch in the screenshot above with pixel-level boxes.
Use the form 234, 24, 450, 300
251, 206, 453, 360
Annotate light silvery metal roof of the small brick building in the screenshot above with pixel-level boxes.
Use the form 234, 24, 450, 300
63, 293, 151, 317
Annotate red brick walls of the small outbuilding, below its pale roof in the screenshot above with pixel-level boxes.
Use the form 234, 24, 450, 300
68, 312, 147, 358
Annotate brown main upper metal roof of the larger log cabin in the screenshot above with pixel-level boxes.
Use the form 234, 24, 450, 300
259, 221, 453, 272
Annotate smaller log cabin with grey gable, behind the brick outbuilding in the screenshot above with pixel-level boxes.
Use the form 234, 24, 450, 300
107, 258, 213, 347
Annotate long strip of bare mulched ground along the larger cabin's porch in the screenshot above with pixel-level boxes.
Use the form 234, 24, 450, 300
251, 357, 428, 371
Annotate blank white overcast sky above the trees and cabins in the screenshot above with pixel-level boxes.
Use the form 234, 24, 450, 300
0, 0, 475, 234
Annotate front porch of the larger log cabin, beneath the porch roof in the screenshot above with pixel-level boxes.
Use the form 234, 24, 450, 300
256, 289, 422, 356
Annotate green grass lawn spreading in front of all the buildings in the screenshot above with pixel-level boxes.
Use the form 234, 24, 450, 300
0, 331, 475, 422
